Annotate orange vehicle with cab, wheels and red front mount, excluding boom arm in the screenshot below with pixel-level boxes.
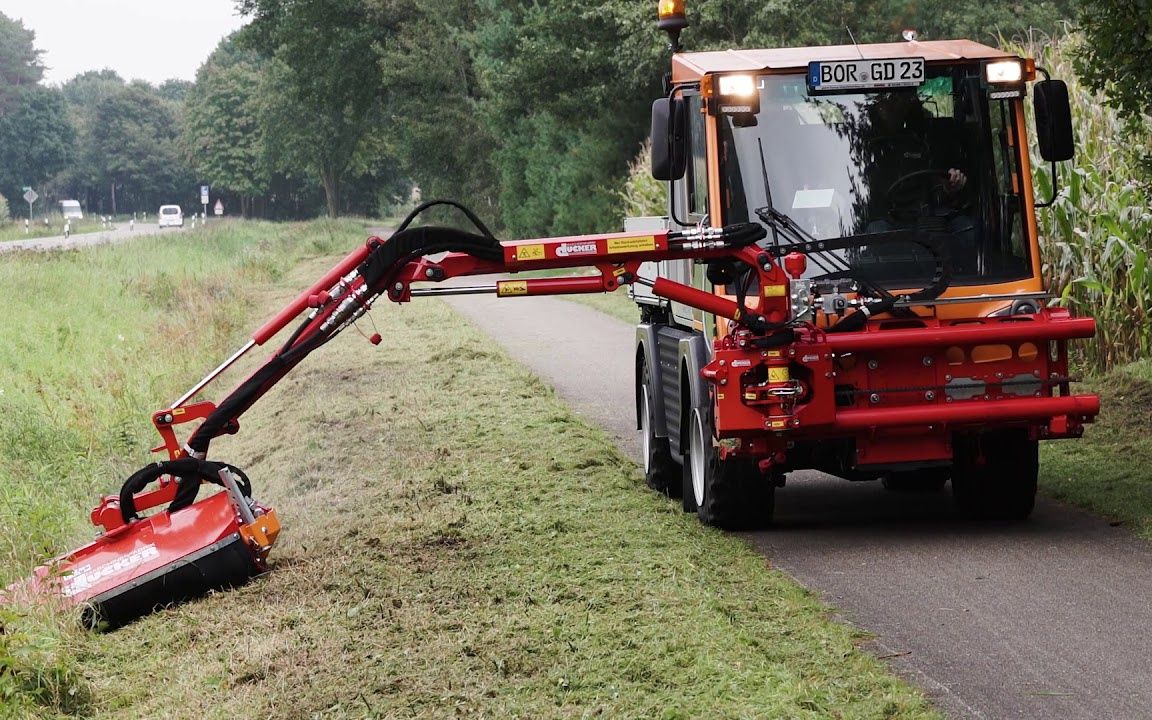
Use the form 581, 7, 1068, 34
630, 8, 1098, 528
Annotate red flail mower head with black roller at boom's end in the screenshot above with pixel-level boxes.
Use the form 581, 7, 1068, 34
9, 457, 280, 627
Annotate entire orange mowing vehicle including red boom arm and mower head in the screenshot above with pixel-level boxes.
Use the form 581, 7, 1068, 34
13, 0, 1099, 624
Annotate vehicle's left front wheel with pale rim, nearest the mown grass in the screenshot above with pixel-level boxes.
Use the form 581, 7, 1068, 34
683, 410, 776, 530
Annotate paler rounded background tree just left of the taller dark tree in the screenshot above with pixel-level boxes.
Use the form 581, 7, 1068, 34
183, 38, 271, 217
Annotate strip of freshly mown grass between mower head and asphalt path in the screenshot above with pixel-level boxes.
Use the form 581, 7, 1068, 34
0, 222, 935, 718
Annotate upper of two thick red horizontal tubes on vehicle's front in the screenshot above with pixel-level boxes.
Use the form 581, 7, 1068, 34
826, 318, 1096, 353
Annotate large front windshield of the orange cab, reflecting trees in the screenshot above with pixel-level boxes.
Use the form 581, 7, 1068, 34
720, 67, 1032, 287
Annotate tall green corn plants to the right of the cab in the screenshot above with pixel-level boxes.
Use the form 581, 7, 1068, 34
1015, 36, 1152, 372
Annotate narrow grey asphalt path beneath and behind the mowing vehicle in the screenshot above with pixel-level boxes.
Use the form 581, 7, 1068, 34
450, 296, 1152, 720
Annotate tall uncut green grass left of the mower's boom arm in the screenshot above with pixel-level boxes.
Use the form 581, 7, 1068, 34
0, 216, 364, 718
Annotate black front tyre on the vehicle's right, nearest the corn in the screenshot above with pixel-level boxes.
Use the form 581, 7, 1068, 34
952, 430, 1040, 522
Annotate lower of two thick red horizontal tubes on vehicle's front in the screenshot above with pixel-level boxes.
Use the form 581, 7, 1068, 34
836, 395, 1100, 430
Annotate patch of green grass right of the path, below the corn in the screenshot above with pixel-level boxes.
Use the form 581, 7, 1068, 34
1040, 361, 1152, 539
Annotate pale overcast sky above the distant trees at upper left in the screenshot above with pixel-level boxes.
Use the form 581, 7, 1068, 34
0, 0, 244, 84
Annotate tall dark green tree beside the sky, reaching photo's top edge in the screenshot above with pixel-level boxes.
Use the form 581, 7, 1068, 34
240, 0, 396, 217
